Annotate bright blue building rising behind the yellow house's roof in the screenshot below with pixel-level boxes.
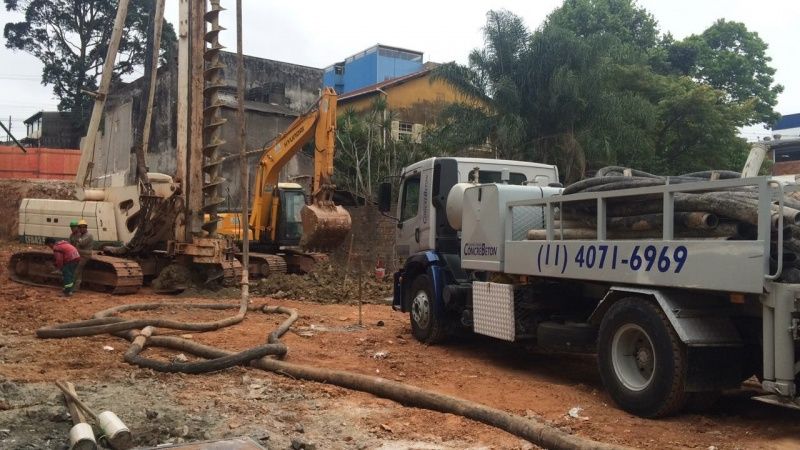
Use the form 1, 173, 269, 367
322, 44, 423, 94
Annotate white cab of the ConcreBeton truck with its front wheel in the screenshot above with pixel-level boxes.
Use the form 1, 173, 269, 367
380, 157, 560, 341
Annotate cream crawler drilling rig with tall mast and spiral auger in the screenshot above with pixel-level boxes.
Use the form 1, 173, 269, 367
9, 0, 262, 294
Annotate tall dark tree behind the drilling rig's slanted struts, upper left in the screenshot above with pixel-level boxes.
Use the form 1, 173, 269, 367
3, 0, 177, 125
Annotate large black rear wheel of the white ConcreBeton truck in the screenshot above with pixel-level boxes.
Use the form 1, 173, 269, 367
597, 297, 687, 418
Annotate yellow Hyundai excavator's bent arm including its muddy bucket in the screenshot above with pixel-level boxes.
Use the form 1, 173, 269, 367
250, 88, 351, 250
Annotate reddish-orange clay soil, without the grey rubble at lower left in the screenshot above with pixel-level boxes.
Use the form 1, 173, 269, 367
0, 245, 800, 449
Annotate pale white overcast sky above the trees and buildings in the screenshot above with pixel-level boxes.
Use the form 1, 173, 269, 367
0, 0, 800, 139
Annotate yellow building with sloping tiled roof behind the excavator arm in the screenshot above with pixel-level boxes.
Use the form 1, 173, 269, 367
338, 68, 476, 142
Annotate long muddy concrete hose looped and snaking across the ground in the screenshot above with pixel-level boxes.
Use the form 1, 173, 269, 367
37, 300, 623, 450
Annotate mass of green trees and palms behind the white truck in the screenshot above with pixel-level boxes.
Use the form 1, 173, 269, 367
430, 0, 782, 182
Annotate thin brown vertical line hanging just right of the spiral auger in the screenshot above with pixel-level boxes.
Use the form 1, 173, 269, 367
236, 0, 250, 302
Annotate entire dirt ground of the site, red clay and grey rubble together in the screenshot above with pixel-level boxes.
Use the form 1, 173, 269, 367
0, 244, 800, 449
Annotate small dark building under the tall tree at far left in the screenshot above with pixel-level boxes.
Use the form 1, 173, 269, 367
20, 111, 83, 149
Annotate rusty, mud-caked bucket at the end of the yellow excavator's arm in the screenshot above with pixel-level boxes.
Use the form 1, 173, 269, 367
300, 204, 352, 251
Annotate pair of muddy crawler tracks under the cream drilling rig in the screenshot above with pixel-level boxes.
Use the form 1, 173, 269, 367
8, 250, 143, 295
